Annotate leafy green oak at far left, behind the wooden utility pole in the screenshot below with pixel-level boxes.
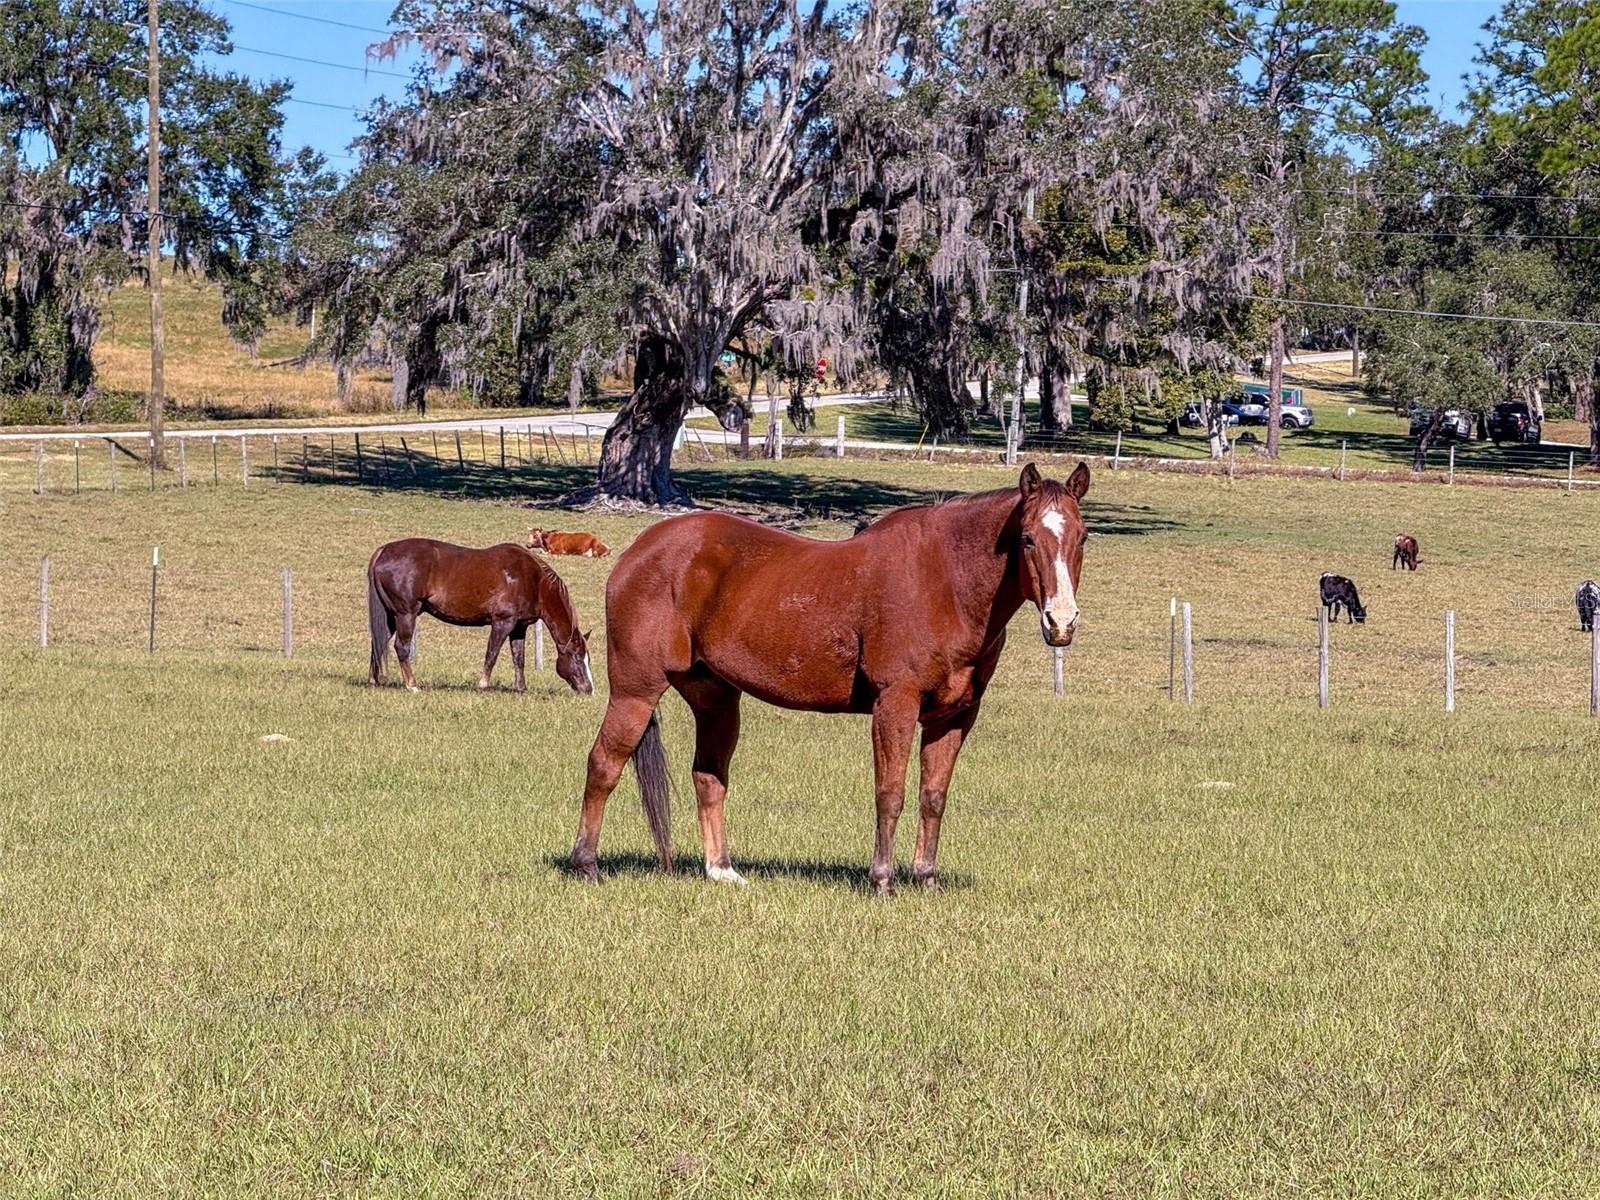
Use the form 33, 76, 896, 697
0, 0, 294, 416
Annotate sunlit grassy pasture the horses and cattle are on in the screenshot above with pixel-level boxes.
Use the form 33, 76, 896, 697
0, 461, 1600, 1197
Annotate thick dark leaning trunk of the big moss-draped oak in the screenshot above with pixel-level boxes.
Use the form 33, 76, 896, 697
595, 336, 690, 504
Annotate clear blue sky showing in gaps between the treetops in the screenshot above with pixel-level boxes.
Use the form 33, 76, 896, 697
213, 0, 1499, 168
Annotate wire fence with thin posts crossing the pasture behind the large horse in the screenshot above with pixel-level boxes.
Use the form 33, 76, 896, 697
0, 531, 1600, 723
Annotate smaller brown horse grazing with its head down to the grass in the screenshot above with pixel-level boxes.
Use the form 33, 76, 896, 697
366, 538, 594, 696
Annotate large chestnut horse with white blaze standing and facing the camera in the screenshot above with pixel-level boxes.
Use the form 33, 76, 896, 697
573, 464, 1090, 894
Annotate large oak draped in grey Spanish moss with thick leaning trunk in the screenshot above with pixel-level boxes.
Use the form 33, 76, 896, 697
332, 0, 902, 504
